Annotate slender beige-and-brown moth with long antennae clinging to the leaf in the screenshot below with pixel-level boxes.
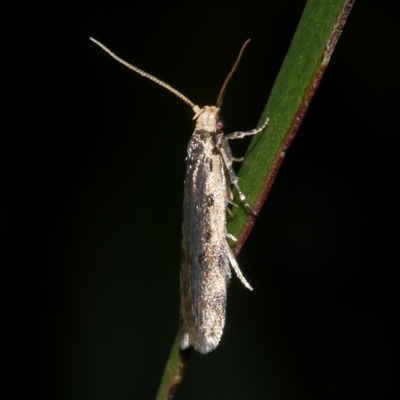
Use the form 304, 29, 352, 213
90, 38, 268, 354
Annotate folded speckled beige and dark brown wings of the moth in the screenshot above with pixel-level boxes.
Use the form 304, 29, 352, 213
180, 130, 230, 353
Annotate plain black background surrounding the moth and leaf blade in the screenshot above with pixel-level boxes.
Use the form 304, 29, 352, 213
1, 0, 400, 400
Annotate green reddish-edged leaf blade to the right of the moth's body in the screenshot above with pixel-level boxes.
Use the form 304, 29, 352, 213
228, 0, 354, 254
